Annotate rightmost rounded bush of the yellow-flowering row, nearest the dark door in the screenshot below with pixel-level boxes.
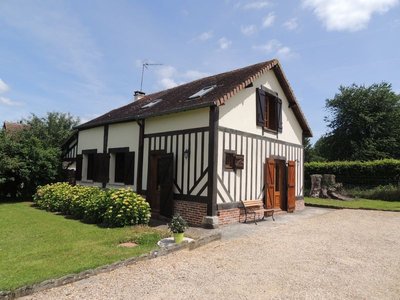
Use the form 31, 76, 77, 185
104, 189, 151, 226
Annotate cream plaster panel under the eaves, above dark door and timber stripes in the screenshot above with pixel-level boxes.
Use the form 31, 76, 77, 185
145, 107, 210, 134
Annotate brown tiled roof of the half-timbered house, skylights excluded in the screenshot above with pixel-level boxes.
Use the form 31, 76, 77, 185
77, 59, 312, 136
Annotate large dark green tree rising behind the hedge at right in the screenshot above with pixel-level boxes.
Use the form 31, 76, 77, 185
316, 82, 400, 161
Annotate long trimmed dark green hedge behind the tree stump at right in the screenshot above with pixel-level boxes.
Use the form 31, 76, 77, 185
304, 159, 400, 188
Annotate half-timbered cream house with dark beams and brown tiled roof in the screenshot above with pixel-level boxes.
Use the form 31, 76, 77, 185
76, 59, 312, 225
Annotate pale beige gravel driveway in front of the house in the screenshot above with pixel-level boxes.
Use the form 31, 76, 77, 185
24, 208, 400, 299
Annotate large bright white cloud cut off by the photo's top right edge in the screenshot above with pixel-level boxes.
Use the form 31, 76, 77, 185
303, 0, 399, 32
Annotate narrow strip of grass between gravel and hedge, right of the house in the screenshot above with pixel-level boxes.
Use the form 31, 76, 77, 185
304, 197, 400, 211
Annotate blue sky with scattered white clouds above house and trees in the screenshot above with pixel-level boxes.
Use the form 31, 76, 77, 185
0, 0, 400, 141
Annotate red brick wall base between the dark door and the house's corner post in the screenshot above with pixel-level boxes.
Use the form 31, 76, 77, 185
174, 200, 207, 225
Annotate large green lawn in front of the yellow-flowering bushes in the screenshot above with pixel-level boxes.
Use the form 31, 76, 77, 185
0, 202, 165, 291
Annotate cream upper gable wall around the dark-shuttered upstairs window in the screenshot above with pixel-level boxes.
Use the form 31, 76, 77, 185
219, 70, 303, 145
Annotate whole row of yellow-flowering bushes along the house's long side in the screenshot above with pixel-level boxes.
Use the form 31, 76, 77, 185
33, 183, 151, 227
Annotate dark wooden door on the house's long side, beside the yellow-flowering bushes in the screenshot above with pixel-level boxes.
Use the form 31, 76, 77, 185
147, 152, 174, 217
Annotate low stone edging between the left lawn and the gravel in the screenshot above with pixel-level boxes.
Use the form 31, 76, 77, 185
0, 232, 221, 300
